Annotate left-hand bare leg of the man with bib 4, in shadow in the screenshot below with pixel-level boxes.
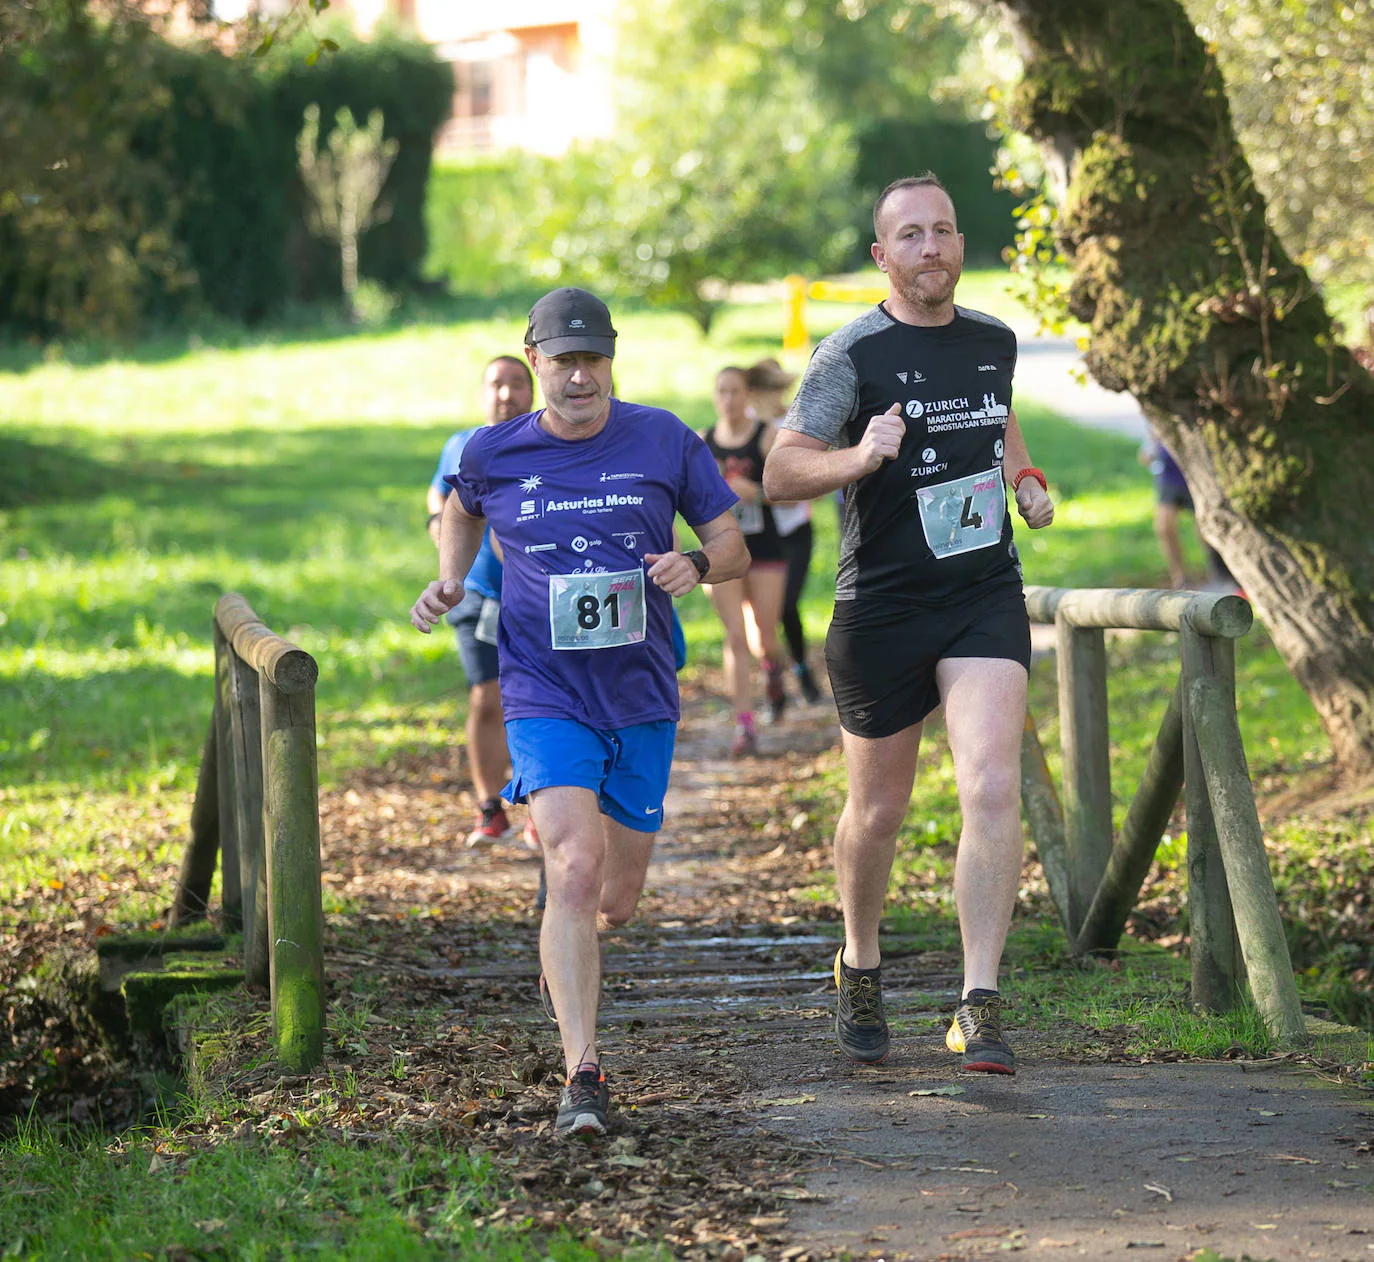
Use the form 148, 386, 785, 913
835, 723, 921, 968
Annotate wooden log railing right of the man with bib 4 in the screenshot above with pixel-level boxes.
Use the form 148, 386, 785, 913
1021, 587, 1308, 1046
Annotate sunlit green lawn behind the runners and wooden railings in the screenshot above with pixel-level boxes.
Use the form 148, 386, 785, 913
0, 281, 1325, 912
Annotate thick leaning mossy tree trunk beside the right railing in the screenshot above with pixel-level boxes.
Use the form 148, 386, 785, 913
999, 0, 1374, 779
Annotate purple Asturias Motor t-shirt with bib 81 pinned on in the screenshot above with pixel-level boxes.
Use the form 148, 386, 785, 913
445, 399, 736, 730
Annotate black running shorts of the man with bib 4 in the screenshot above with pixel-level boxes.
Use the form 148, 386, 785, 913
826, 584, 1031, 740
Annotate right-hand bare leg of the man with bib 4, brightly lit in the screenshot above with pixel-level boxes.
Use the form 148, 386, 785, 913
936, 657, 1026, 994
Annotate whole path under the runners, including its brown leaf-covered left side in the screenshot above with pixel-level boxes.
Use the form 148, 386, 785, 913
295, 690, 1374, 1262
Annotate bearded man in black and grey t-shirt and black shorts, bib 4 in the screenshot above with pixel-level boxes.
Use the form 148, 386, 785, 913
764, 173, 1054, 1074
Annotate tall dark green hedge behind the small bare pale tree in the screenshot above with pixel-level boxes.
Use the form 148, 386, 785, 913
0, 8, 453, 337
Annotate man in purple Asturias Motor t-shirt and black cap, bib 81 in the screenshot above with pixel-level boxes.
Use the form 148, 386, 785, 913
411, 289, 749, 1136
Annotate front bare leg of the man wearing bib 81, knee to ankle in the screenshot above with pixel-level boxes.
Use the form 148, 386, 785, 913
529, 785, 606, 1076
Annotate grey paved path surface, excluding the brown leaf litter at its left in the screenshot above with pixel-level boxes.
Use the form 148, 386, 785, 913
436, 697, 1374, 1262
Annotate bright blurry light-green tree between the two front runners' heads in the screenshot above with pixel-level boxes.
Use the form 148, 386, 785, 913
532, 0, 853, 330
